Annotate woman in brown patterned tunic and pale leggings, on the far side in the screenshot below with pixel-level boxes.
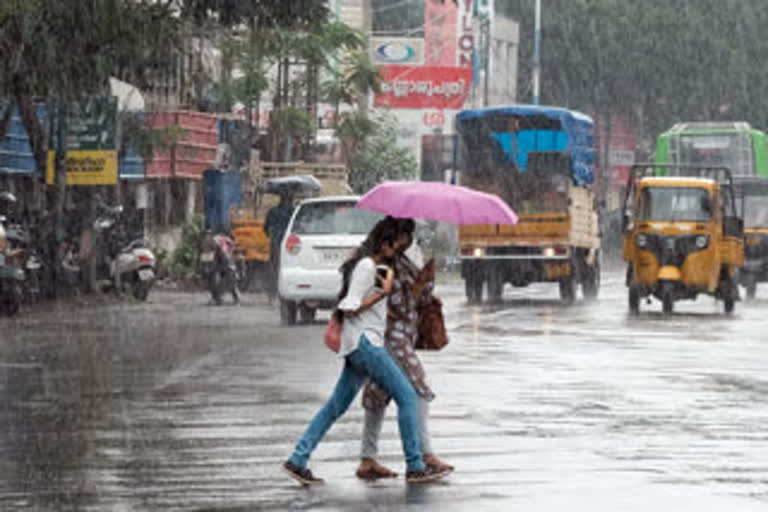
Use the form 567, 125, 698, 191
357, 217, 453, 480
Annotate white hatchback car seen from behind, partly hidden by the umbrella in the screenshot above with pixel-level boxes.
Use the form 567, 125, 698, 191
278, 196, 383, 325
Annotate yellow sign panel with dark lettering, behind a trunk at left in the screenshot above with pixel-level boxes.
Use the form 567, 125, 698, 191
45, 149, 117, 185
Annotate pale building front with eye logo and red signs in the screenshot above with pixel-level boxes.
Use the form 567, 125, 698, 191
338, 0, 519, 181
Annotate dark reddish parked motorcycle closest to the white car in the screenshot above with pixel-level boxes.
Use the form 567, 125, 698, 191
200, 232, 240, 306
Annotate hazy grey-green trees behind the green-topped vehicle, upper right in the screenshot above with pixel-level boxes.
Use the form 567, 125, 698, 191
509, 0, 768, 137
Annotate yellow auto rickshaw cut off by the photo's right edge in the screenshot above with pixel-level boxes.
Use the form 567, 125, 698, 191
735, 177, 768, 300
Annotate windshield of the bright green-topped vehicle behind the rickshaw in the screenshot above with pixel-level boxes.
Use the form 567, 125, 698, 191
671, 133, 755, 176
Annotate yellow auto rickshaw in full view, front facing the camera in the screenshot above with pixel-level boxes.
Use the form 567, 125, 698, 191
623, 164, 744, 314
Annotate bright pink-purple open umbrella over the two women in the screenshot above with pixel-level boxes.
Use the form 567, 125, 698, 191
357, 181, 517, 224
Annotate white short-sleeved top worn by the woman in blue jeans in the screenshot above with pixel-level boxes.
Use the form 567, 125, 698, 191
338, 258, 387, 357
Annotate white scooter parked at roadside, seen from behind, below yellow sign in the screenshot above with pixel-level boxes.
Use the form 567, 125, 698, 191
93, 206, 156, 301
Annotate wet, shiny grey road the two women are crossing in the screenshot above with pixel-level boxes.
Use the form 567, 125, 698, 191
0, 273, 768, 511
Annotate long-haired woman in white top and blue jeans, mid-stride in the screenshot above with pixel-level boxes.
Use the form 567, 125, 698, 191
283, 222, 448, 485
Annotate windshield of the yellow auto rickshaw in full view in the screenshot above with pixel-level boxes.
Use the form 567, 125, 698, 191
638, 187, 712, 222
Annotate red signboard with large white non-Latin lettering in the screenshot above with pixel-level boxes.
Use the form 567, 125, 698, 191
374, 66, 472, 110
